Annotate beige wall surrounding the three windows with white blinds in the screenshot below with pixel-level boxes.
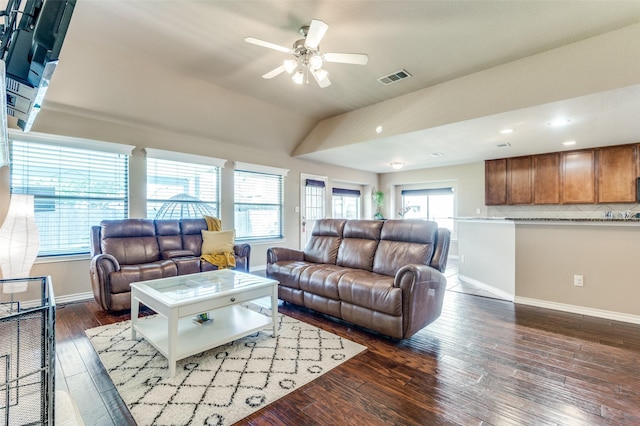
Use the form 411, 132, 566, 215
0, 110, 377, 300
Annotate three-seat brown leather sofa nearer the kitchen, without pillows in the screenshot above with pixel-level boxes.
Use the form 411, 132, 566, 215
266, 219, 450, 338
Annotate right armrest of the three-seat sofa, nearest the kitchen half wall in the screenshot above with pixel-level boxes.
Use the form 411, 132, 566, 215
393, 264, 447, 338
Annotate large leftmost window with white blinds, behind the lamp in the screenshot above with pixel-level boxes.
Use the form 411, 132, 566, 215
10, 135, 132, 256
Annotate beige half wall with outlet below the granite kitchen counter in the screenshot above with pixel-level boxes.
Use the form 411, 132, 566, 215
516, 224, 640, 316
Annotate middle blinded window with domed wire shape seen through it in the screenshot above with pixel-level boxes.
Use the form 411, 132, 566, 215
145, 148, 225, 219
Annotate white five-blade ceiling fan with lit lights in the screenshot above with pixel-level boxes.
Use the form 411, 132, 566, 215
244, 19, 369, 88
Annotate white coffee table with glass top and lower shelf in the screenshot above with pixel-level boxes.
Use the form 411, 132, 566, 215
131, 269, 278, 377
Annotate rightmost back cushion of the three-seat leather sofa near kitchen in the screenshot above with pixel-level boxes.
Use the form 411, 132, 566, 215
373, 220, 438, 276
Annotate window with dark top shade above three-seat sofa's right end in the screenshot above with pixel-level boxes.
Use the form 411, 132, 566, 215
398, 188, 454, 232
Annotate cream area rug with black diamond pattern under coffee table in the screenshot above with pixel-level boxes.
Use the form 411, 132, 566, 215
86, 305, 366, 425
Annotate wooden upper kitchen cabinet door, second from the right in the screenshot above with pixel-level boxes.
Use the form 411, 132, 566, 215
561, 149, 596, 204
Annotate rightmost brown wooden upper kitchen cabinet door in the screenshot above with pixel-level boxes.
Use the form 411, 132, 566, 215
596, 145, 638, 203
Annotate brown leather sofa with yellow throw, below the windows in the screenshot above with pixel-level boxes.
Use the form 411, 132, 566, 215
90, 219, 251, 312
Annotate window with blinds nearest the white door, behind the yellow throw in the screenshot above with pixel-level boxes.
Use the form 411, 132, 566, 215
234, 163, 287, 240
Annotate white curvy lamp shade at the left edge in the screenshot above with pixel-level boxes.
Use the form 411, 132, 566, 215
0, 194, 40, 282
